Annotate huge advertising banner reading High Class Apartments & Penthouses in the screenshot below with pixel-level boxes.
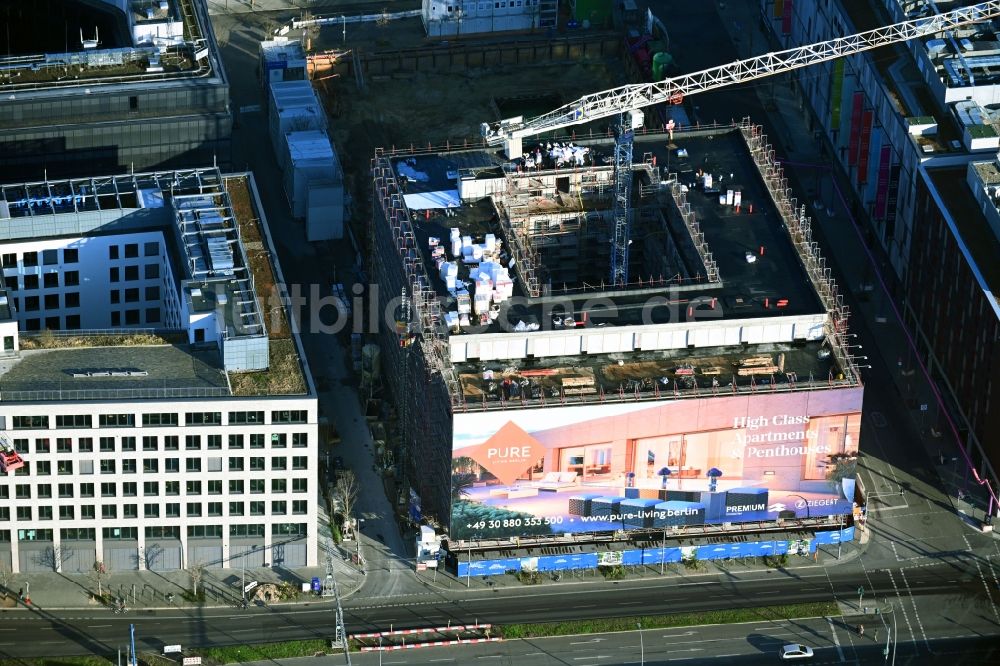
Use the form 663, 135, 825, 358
450, 387, 863, 536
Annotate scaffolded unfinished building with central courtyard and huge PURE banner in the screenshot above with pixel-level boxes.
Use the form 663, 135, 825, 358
371, 121, 862, 541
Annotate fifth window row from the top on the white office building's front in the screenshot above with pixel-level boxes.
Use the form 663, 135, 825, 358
0, 500, 309, 522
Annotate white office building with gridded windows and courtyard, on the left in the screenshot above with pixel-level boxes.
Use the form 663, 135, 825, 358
0, 169, 318, 572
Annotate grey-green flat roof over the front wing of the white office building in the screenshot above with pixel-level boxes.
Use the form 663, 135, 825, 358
0, 345, 229, 402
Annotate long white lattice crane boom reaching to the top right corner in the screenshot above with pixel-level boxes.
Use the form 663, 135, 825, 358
482, 0, 1000, 153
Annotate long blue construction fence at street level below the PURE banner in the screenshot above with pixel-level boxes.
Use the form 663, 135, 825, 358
453, 527, 854, 577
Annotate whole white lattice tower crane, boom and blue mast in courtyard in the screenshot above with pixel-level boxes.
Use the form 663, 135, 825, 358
480, 0, 1000, 285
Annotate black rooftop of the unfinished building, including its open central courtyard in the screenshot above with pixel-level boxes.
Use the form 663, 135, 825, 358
393, 129, 825, 333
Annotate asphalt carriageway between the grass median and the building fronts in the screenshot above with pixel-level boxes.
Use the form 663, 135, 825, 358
0, 564, 997, 663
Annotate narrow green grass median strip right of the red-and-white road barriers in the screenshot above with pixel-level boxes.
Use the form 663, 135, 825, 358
498, 601, 840, 640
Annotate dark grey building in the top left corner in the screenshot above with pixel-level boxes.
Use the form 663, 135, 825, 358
0, 0, 232, 182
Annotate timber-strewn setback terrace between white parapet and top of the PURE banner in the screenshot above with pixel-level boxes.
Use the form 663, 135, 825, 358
454, 341, 857, 409
